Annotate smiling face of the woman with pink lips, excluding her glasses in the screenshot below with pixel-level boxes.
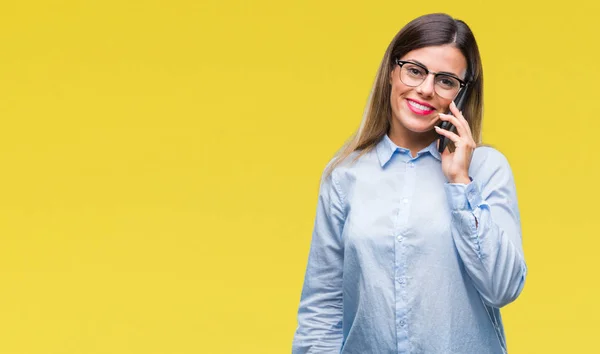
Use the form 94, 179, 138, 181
390, 45, 467, 145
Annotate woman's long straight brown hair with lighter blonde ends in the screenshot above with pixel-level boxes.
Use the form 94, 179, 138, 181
326, 13, 483, 174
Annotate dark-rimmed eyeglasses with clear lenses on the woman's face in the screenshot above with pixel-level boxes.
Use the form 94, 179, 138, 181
396, 59, 467, 100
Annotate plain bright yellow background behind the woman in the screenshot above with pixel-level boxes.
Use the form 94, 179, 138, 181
0, 0, 600, 354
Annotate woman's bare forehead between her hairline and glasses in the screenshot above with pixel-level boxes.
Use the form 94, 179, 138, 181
400, 45, 467, 78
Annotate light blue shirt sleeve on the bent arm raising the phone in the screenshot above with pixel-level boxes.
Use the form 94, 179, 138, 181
445, 150, 527, 308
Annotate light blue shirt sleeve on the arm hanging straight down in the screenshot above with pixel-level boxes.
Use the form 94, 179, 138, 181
292, 170, 344, 354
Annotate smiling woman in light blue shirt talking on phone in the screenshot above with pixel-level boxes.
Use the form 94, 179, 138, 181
293, 14, 527, 354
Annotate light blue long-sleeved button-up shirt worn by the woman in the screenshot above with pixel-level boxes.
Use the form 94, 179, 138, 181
292, 135, 527, 354
